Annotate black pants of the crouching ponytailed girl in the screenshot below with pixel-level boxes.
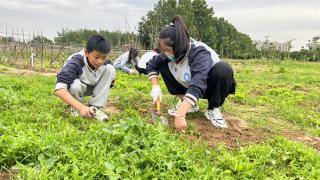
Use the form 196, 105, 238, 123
159, 61, 236, 109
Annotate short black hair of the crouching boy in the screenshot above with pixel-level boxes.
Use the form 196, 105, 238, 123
86, 34, 111, 54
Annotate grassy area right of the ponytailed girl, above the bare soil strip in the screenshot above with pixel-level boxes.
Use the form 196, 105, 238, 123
225, 61, 320, 136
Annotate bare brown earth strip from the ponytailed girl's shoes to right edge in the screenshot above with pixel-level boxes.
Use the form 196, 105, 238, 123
143, 110, 320, 151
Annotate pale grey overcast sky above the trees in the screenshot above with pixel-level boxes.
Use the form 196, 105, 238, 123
0, 0, 320, 49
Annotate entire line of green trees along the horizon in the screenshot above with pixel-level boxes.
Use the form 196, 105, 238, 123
0, 0, 320, 61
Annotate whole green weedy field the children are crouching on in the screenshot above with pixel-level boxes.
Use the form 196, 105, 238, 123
0, 60, 320, 179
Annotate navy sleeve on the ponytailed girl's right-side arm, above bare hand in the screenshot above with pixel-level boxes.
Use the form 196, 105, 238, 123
186, 47, 213, 99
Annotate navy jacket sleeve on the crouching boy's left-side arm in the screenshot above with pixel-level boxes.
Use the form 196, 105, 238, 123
57, 55, 84, 88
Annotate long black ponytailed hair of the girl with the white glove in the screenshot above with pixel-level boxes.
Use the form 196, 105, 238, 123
159, 16, 190, 61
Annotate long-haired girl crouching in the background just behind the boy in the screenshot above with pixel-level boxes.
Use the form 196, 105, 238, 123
113, 48, 138, 74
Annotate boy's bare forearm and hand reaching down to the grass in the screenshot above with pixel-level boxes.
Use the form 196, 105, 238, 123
54, 88, 94, 117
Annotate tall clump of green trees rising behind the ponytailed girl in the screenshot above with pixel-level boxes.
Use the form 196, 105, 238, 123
138, 0, 256, 58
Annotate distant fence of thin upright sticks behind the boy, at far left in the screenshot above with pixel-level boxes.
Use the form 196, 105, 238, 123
0, 29, 146, 69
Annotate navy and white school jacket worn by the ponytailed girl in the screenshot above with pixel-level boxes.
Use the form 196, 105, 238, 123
147, 39, 220, 105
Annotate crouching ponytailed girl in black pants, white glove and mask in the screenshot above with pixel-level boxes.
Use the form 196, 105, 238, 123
147, 16, 236, 130
